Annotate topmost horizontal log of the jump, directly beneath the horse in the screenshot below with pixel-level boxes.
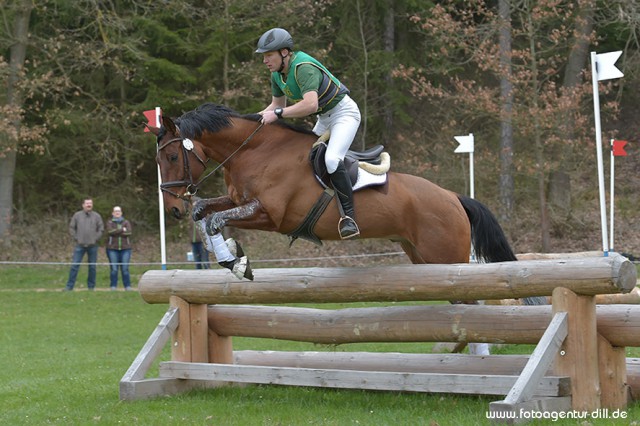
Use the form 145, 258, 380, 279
138, 255, 637, 304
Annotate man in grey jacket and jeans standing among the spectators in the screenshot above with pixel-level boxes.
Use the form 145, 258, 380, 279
65, 198, 104, 291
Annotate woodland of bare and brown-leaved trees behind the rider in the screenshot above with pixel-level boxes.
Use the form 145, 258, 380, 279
0, 0, 640, 261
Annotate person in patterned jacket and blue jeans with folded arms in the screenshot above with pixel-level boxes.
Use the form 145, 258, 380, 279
107, 206, 132, 291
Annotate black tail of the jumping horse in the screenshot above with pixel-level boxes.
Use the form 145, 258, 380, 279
458, 195, 547, 305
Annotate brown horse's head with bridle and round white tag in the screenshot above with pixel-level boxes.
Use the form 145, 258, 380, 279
149, 117, 207, 219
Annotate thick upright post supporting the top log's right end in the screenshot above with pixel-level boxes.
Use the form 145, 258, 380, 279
553, 287, 601, 411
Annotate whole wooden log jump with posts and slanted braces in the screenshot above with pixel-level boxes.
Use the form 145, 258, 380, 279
120, 254, 640, 422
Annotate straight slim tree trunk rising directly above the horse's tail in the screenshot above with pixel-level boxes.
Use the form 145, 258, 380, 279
499, 0, 514, 225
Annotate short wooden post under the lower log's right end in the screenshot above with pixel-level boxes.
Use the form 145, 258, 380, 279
598, 334, 630, 409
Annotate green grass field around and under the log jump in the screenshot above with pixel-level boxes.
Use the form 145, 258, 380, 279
0, 265, 640, 426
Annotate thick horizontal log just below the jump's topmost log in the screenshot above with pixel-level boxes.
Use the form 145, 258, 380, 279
208, 305, 640, 347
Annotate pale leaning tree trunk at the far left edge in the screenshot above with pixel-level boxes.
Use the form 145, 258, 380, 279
0, 0, 33, 239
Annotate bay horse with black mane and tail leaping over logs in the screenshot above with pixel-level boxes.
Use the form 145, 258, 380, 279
150, 103, 544, 302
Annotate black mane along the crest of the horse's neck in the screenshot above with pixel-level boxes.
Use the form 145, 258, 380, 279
175, 102, 313, 139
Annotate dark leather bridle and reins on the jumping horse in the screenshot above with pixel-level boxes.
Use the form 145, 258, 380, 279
158, 122, 264, 201
